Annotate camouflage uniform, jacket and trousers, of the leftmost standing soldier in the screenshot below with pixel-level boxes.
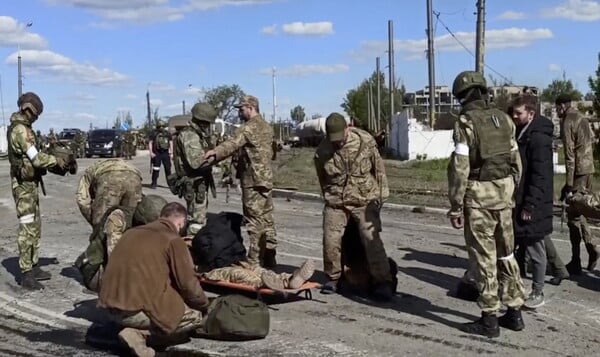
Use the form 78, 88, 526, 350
8, 112, 61, 273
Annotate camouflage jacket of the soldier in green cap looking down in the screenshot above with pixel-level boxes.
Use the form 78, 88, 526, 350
314, 128, 389, 207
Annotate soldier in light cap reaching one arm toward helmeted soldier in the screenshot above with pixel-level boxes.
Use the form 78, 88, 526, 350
204, 95, 277, 268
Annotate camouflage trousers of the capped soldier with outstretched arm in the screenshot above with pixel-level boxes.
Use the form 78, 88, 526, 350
242, 187, 277, 265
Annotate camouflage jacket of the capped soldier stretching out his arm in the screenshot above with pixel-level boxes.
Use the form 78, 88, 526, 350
215, 115, 273, 189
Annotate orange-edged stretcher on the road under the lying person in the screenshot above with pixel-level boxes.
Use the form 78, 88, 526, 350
198, 276, 321, 300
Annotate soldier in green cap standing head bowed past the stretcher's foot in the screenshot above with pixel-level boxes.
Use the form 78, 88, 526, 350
314, 113, 395, 300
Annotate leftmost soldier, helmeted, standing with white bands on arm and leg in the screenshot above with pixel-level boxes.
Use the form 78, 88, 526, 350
7, 92, 66, 290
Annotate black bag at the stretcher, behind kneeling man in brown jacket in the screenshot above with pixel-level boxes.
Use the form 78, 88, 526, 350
190, 212, 246, 271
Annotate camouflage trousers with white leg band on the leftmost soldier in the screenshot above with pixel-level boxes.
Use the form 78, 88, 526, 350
12, 179, 42, 273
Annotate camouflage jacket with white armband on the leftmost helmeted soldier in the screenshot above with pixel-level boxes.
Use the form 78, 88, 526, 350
7, 112, 56, 181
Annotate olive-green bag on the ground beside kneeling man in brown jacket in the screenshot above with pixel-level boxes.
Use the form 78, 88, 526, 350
203, 295, 270, 341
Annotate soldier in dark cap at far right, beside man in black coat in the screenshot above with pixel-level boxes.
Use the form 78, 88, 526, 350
555, 94, 598, 275
